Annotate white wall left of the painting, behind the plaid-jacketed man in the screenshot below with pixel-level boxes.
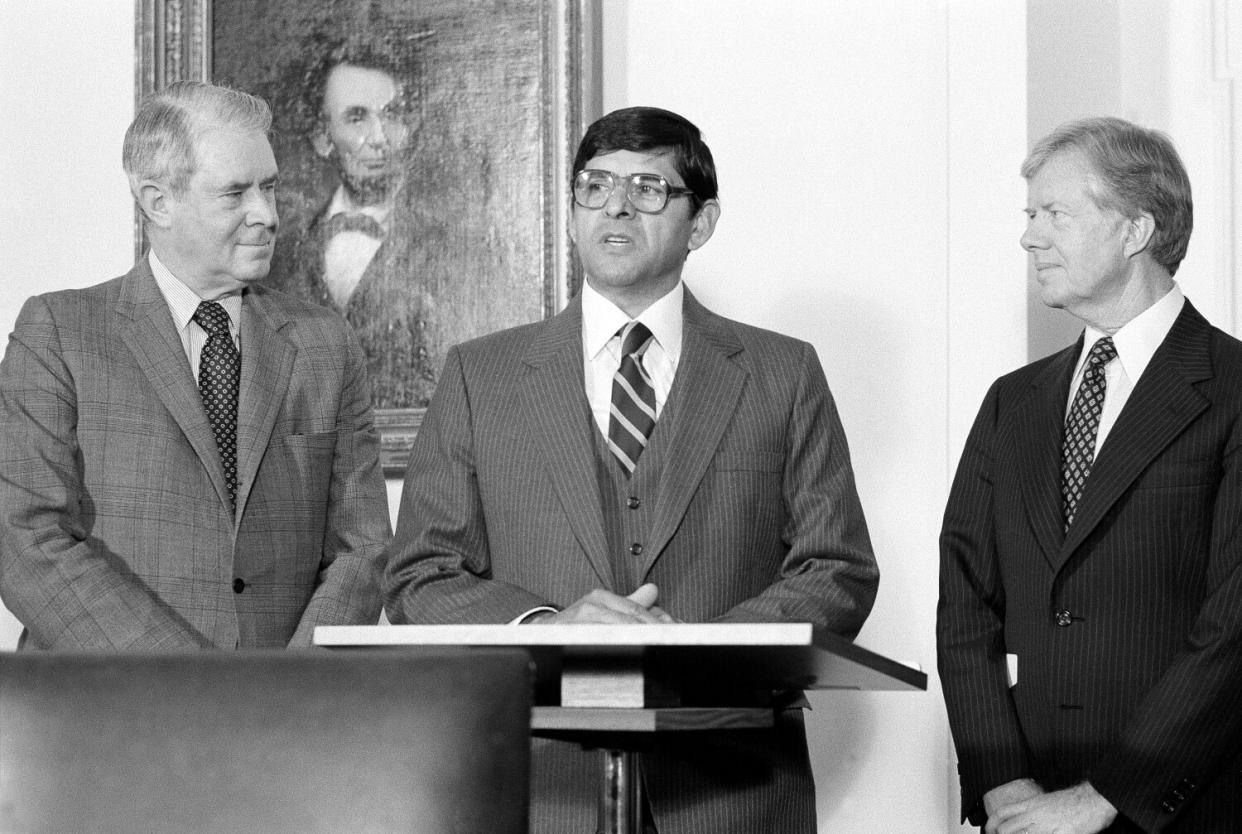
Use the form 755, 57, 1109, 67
0, 0, 134, 649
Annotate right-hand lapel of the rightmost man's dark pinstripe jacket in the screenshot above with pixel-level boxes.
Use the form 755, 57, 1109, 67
1056, 301, 1212, 567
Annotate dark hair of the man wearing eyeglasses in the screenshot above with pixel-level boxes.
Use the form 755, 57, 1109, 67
574, 107, 717, 211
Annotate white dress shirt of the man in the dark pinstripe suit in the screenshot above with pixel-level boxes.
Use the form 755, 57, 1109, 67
1066, 283, 1186, 455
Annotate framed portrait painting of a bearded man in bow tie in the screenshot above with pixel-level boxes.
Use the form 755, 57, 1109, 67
138, 0, 599, 472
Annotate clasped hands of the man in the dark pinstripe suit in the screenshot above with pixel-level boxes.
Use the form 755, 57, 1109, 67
984, 779, 1117, 834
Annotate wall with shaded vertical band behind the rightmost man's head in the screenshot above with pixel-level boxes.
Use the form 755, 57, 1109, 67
1027, 0, 1242, 359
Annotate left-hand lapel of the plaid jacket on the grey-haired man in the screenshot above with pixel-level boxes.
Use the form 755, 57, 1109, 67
116, 257, 229, 503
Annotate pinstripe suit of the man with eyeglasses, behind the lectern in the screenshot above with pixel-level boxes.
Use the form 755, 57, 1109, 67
385, 293, 877, 834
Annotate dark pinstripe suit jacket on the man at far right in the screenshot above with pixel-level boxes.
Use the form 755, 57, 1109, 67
938, 302, 1242, 834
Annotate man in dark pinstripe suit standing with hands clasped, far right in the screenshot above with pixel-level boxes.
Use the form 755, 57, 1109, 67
938, 118, 1242, 834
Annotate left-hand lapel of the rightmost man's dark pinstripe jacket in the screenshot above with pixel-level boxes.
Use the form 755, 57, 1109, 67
1012, 338, 1082, 566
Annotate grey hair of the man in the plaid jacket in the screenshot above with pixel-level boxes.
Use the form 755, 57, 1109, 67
120, 81, 272, 198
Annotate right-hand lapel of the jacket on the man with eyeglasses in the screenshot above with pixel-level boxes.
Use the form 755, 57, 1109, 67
642, 295, 746, 575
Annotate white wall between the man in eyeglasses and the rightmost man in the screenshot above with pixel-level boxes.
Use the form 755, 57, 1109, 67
604, 0, 1026, 833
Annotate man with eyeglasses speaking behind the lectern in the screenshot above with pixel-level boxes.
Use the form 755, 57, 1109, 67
385, 107, 878, 834
